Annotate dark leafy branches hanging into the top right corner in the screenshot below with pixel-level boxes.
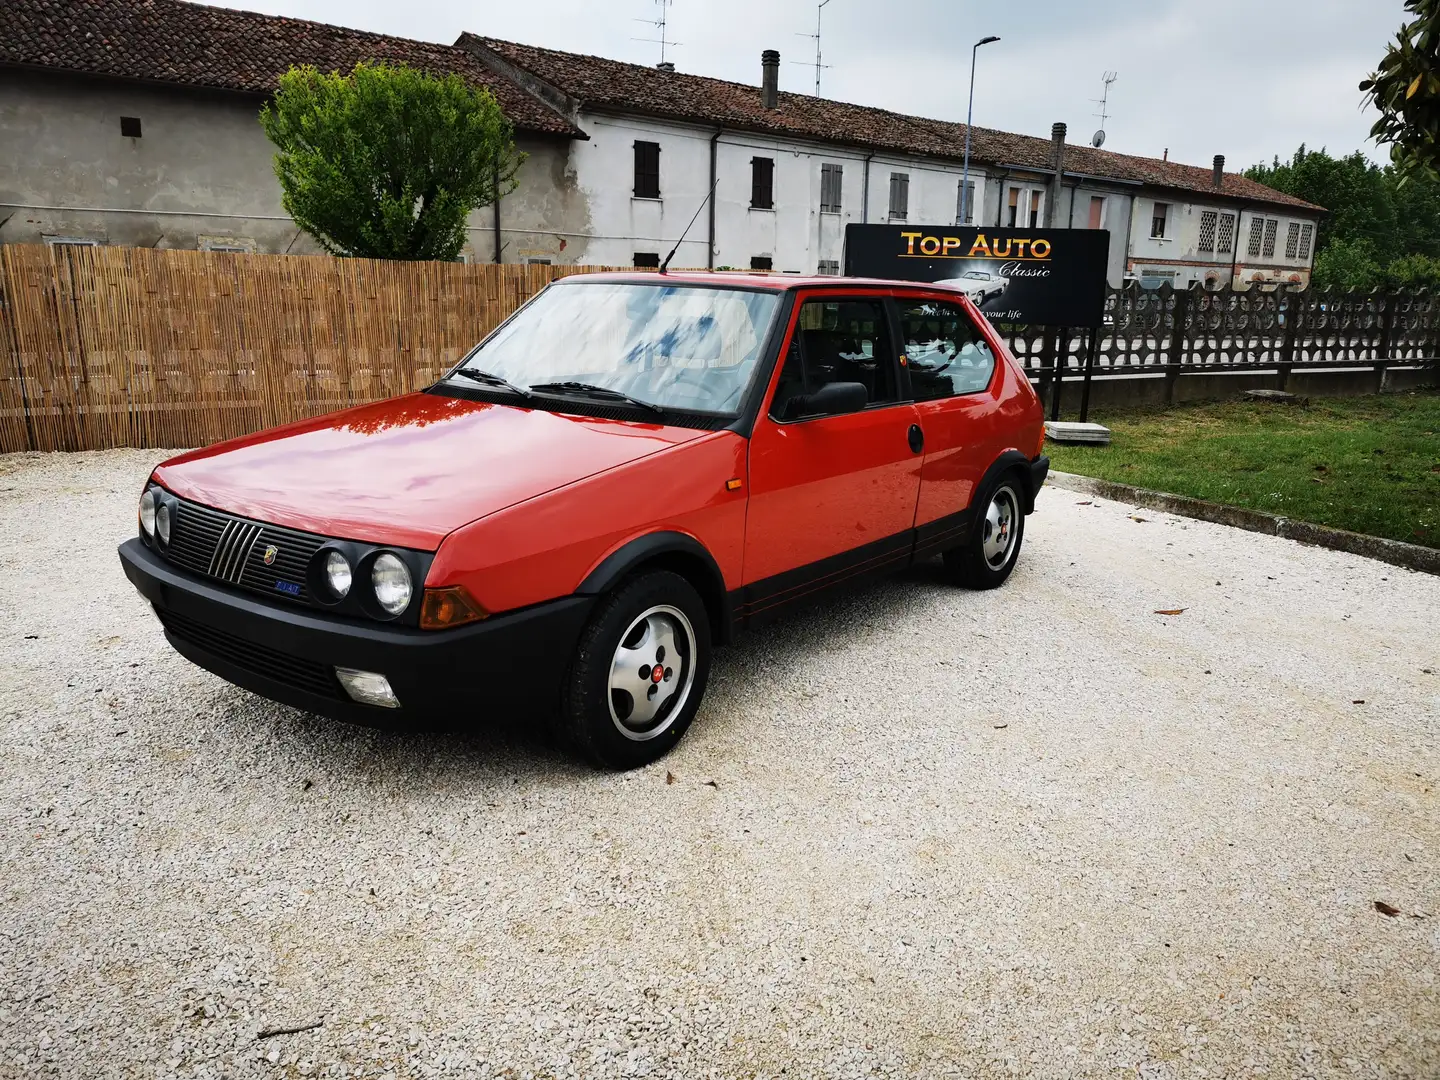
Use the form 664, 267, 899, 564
1359, 0, 1440, 183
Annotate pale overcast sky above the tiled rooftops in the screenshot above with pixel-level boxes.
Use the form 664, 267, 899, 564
241, 0, 1404, 170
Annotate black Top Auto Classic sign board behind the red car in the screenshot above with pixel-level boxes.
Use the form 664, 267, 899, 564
845, 225, 1110, 327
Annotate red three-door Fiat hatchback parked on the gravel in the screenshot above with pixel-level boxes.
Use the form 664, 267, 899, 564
120, 274, 1048, 768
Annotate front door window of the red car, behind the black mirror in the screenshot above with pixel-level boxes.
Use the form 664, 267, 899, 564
770, 300, 900, 420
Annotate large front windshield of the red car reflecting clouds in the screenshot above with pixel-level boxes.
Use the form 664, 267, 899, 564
454, 282, 779, 413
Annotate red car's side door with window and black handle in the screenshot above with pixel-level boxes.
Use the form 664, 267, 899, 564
744, 291, 922, 613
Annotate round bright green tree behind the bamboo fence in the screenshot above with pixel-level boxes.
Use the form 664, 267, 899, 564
261, 63, 523, 259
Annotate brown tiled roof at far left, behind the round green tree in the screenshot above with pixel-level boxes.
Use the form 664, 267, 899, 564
0, 0, 583, 137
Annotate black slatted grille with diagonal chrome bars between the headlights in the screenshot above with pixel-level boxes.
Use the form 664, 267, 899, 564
166, 501, 325, 603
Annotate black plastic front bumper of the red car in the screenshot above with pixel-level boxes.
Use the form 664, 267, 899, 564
120, 537, 595, 726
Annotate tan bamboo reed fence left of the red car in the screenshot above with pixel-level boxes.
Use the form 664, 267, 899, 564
0, 245, 624, 452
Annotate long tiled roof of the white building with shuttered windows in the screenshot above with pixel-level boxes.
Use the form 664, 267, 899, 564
456, 35, 1320, 210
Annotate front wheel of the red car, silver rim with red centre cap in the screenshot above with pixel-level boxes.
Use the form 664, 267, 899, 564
560, 570, 710, 770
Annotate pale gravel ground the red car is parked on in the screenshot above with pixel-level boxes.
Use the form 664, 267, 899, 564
0, 451, 1440, 1079
